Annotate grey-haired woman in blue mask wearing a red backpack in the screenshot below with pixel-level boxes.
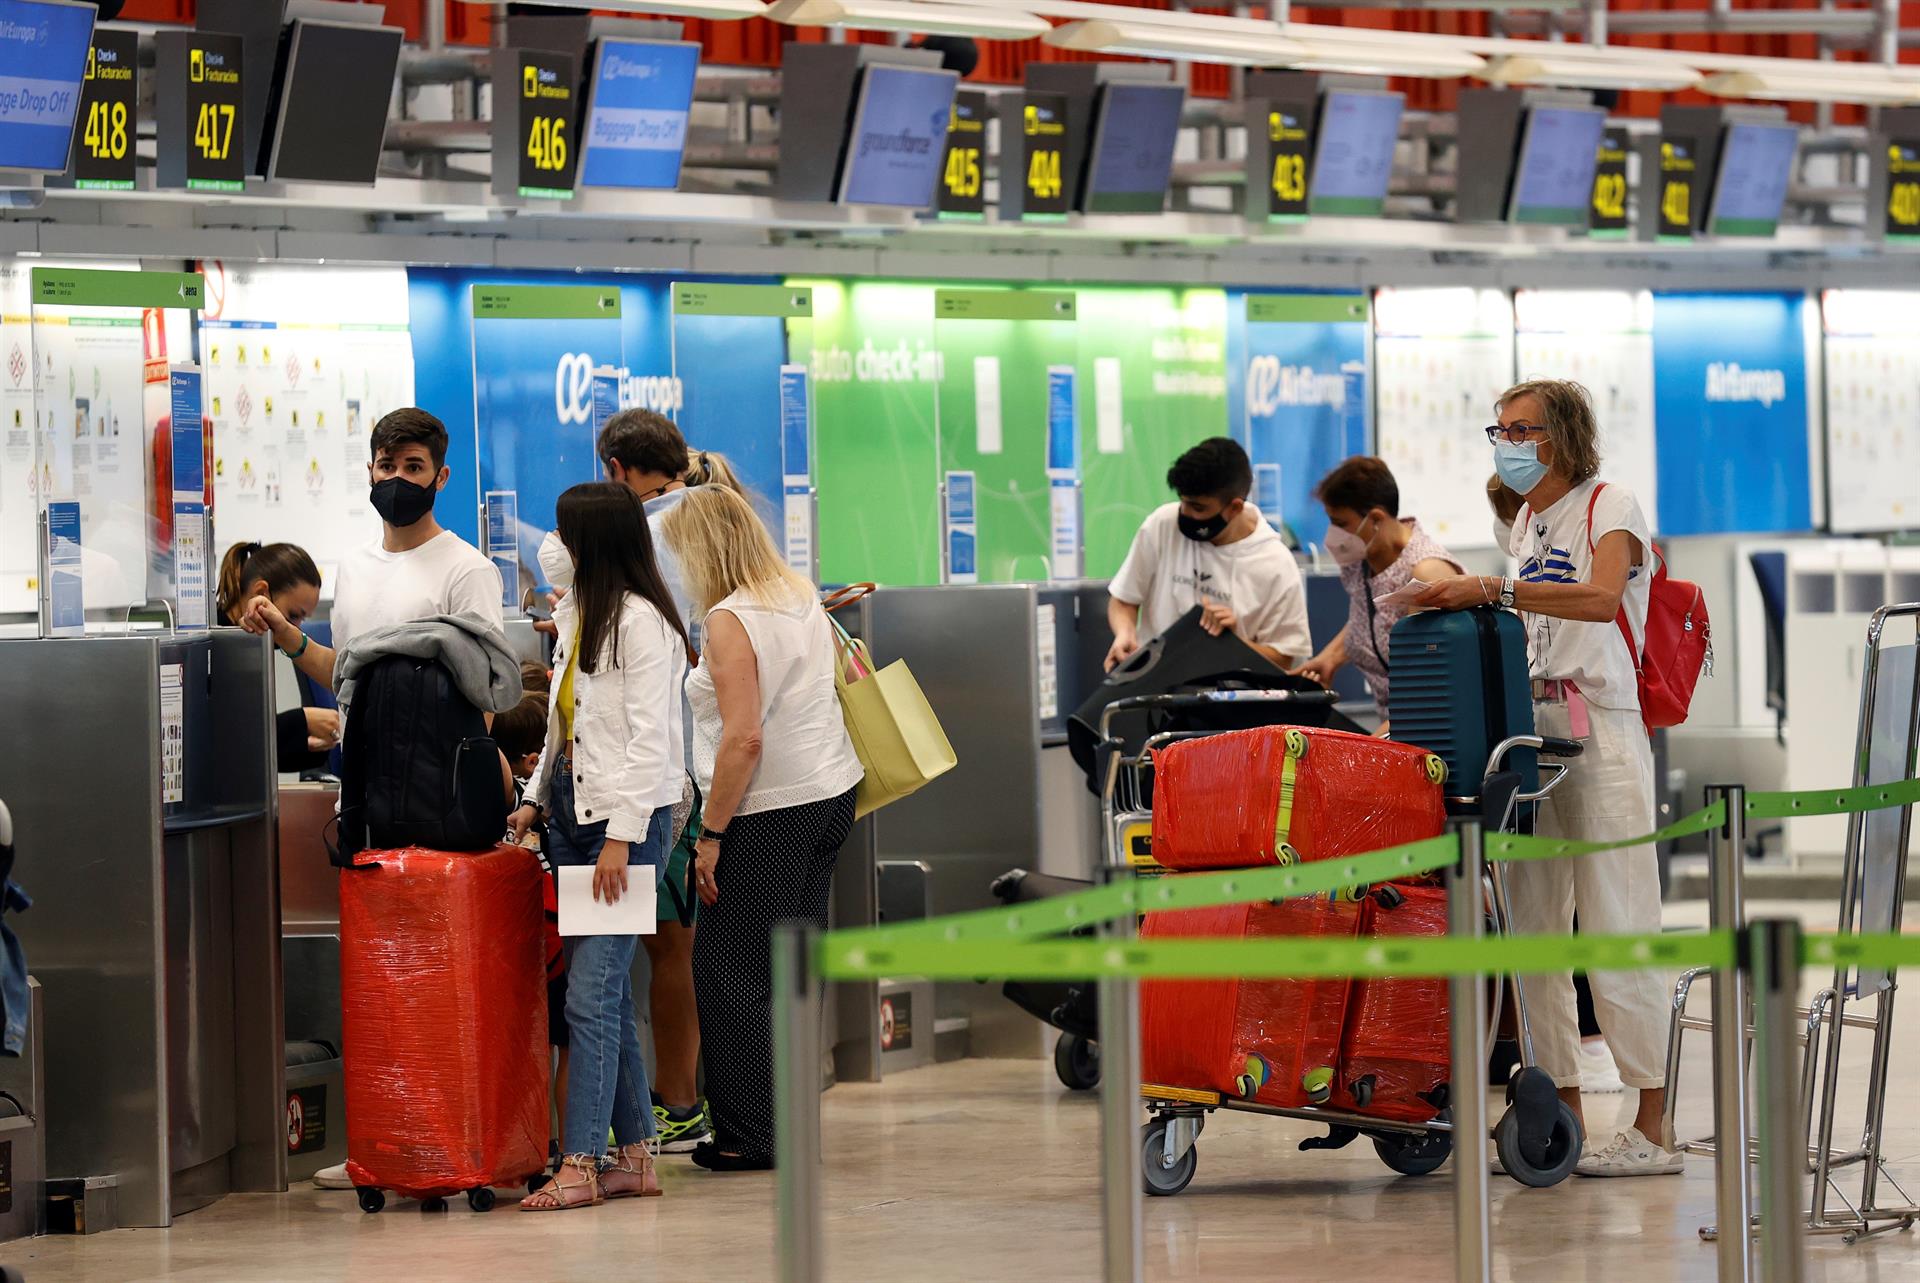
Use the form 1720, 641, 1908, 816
1415, 378, 1682, 1175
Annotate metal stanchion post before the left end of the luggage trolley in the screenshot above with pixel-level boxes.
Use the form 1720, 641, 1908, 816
1100, 868, 1142, 1283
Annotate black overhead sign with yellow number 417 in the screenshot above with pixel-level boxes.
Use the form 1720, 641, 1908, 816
154, 31, 248, 192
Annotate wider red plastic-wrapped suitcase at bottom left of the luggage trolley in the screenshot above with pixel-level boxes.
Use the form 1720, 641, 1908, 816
1140, 899, 1363, 1108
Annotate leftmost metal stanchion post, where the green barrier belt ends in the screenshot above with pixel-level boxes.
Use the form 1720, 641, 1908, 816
774, 922, 826, 1283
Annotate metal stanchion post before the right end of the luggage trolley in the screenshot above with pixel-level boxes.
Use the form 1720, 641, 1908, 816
1448, 818, 1494, 1283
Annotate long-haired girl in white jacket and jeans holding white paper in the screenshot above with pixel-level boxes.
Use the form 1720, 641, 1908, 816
513, 482, 693, 1212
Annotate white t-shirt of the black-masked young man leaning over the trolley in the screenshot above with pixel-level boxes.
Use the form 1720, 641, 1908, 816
1110, 503, 1313, 663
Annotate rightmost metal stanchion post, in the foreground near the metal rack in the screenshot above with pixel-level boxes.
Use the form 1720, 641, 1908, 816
1751, 918, 1807, 1283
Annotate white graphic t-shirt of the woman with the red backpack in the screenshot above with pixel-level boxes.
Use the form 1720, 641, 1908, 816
1507, 480, 1653, 711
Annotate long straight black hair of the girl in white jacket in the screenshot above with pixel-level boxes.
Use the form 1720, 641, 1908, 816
555, 482, 693, 672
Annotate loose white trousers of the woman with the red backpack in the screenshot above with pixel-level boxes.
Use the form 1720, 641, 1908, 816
1505, 701, 1672, 1087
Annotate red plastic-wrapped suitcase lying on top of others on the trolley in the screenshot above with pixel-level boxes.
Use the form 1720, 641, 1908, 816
1154, 726, 1446, 868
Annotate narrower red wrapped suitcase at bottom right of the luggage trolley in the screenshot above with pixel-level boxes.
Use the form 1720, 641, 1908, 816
1334, 882, 1452, 1122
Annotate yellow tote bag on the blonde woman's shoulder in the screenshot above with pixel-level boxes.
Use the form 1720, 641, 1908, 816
828, 617, 960, 818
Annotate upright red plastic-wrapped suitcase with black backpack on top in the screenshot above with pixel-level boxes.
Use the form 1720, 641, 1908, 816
340, 845, 549, 1210
